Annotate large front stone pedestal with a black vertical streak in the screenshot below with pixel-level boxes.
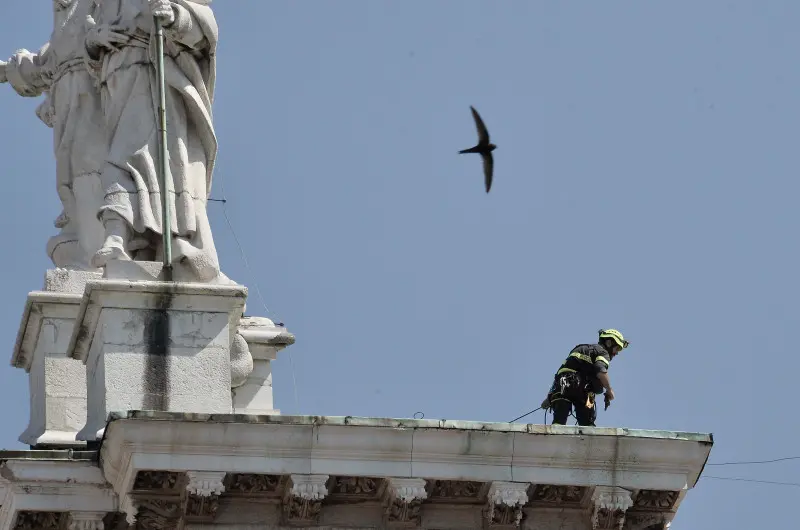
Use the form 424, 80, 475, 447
67, 274, 247, 441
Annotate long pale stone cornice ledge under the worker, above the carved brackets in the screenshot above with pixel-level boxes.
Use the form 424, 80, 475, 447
101, 412, 713, 504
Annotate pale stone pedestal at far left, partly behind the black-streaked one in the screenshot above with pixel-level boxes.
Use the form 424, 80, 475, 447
11, 269, 100, 448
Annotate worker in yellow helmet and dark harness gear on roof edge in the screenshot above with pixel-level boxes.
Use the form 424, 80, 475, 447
542, 329, 628, 427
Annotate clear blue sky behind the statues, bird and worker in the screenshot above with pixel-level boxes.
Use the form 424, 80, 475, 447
0, 0, 800, 529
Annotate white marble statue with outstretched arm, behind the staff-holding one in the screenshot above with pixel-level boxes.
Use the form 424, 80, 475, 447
0, 0, 106, 270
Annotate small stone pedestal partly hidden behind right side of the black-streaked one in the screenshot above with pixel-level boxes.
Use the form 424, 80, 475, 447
233, 317, 294, 415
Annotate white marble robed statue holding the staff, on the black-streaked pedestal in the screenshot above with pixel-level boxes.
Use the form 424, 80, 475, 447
86, 0, 224, 282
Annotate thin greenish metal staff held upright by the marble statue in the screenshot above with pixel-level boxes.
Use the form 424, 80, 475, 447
154, 17, 172, 281
